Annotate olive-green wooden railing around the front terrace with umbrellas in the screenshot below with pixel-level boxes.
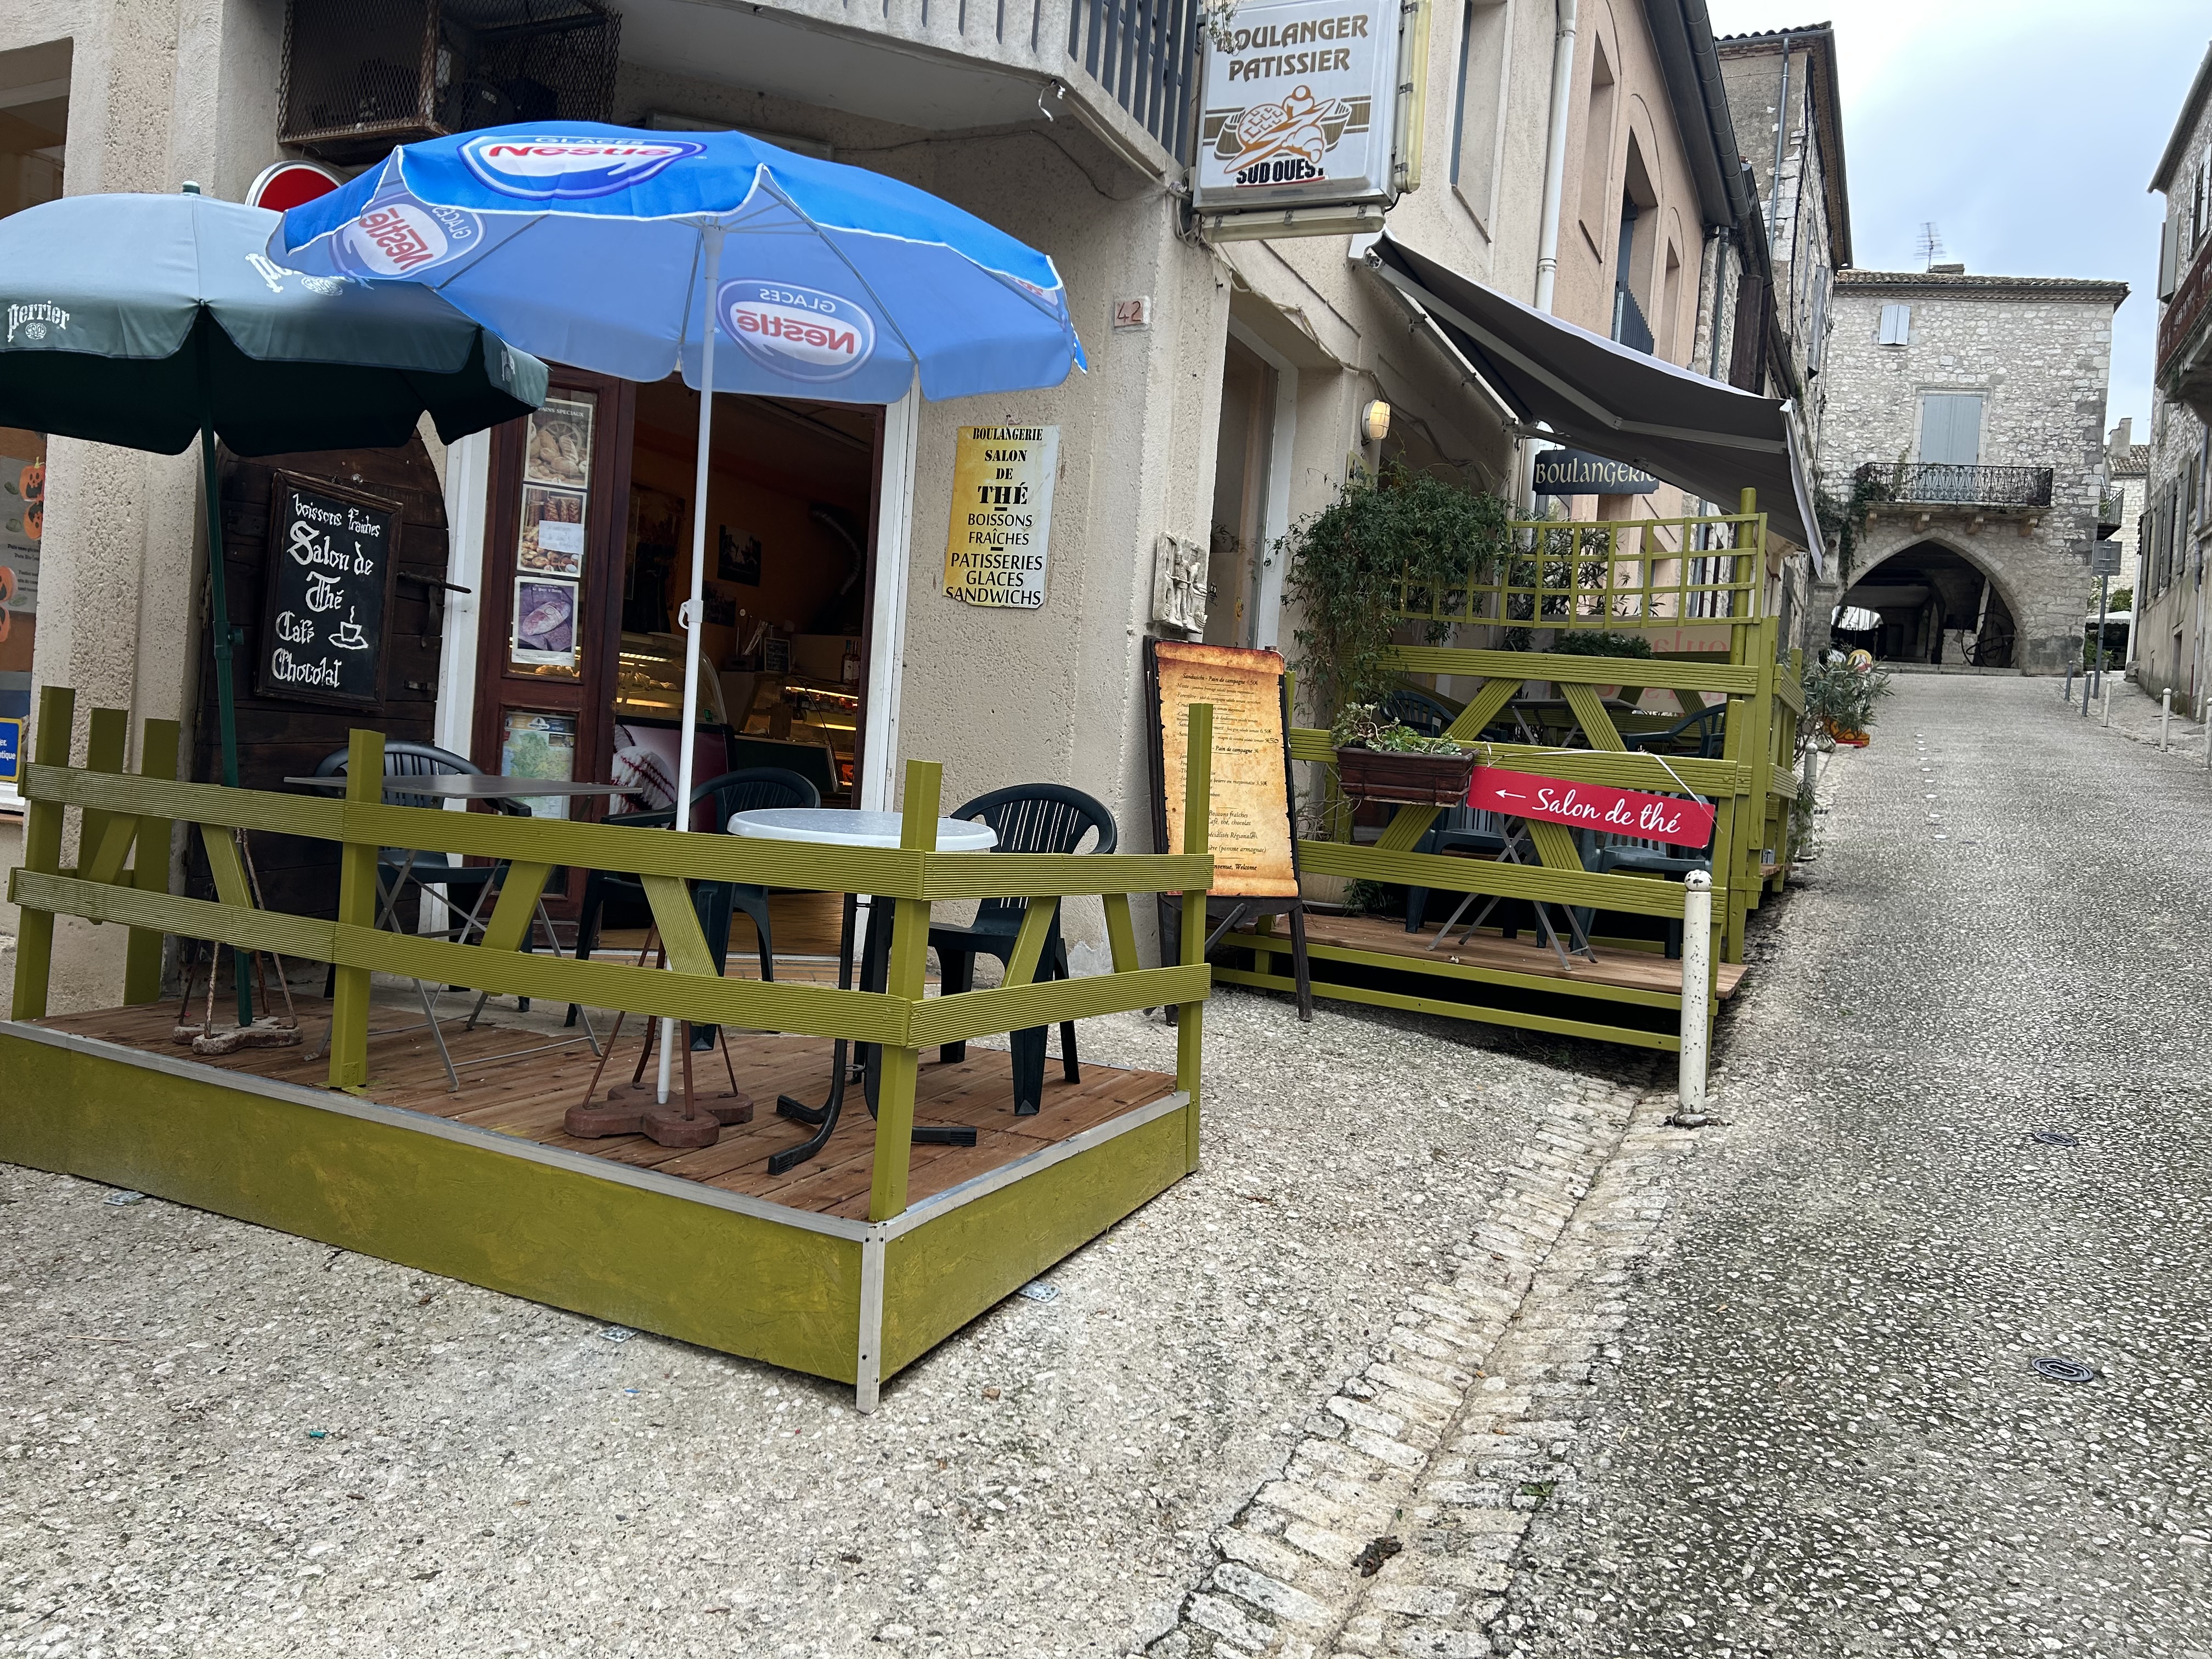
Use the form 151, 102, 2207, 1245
9, 686, 1212, 1221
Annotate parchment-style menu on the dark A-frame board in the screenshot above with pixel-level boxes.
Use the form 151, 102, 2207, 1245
1150, 639, 1299, 898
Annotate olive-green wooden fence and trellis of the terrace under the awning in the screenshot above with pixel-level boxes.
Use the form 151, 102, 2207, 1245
1217, 491, 1803, 1048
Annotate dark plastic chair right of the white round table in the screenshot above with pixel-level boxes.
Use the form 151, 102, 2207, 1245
929, 783, 1121, 1117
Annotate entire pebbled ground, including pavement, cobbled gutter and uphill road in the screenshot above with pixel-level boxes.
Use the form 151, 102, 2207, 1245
0, 677, 2212, 1659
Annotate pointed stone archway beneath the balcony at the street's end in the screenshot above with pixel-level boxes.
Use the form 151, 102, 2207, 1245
1827, 513, 2097, 675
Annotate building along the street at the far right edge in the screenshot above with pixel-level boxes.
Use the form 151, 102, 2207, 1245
2135, 37, 2212, 714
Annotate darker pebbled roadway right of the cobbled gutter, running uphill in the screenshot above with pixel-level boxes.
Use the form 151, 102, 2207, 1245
1487, 677, 2212, 1659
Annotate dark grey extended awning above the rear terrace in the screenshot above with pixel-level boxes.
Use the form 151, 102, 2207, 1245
1367, 234, 1822, 571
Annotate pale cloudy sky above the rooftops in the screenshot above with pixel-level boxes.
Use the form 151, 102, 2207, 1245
1708, 0, 2212, 442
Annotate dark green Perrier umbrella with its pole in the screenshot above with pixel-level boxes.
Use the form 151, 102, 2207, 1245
0, 184, 546, 1024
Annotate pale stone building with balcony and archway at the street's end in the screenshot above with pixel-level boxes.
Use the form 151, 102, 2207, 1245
1820, 266, 2128, 675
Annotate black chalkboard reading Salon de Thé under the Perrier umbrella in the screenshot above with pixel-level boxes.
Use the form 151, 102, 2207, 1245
259, 473, 400, 703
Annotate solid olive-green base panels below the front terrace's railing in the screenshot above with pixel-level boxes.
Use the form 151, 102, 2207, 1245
0, 1020, 1197, 1409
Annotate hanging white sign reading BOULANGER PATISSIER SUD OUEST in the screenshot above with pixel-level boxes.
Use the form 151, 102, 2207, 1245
1192, 0, 1400, 212
